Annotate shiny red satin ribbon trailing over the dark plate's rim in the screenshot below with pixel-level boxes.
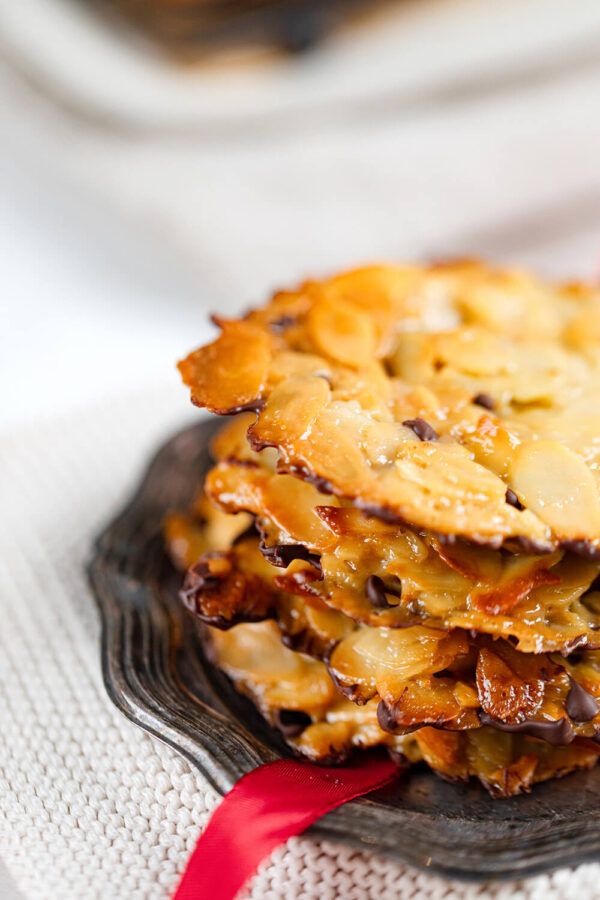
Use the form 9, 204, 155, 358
174, 755, 399, 900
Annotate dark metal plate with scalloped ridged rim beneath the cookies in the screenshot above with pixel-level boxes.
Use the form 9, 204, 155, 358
89, 420, 600, 880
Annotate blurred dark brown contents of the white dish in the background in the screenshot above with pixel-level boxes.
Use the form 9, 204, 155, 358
91, 0, 371, 56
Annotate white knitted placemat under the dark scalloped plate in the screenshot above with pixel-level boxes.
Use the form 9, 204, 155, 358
0, 384, 600, 900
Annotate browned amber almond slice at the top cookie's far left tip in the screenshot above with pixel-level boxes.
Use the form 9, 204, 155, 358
179, 320, 271, 414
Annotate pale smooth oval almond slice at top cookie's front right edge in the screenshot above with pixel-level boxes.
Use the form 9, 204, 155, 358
511, 441, 600, 540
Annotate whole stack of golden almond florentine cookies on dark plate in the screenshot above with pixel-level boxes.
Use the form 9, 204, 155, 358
167, 263, 600, 796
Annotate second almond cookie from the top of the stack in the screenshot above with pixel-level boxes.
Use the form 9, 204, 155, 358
206, 458, 600, 652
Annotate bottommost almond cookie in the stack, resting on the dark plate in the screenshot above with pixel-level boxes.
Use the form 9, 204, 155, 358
208, 622, 600, 797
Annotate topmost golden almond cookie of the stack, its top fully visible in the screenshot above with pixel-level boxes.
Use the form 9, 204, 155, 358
181, 263, 600, 554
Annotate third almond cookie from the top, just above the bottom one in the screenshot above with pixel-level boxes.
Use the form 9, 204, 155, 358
165, 520, 600, 744
